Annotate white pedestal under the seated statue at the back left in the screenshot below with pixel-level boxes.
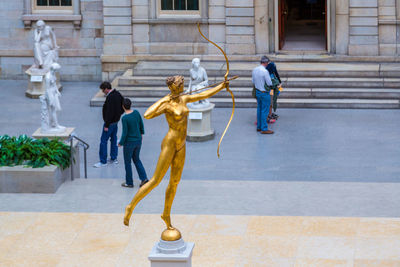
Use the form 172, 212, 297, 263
25, 67, 62, 98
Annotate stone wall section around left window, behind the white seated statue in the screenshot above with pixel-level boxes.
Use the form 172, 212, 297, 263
0, 0, 103, 80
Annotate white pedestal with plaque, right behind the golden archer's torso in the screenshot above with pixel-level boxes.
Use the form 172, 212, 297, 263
186, 103, 215, 142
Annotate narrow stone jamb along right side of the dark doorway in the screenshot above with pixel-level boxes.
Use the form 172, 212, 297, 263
336, 0, 349, 55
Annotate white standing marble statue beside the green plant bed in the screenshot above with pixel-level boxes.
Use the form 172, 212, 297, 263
40, 63, 65, 133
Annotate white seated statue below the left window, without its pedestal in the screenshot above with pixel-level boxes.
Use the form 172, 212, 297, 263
33, 20, 59, 69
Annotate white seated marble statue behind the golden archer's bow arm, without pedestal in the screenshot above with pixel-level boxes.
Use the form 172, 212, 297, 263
187, 58, 210, 108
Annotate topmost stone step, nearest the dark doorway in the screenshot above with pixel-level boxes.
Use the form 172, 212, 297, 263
133, 61, 400, 78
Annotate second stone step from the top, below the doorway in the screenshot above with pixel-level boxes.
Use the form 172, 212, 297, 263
118, 76, 400, 88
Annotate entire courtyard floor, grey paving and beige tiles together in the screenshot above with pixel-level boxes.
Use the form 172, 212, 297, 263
0, 80, 400, 267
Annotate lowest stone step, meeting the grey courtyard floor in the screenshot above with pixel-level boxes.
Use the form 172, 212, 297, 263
90, 94, 400, 109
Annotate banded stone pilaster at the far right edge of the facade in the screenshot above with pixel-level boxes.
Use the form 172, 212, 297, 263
378, 0, 397, 56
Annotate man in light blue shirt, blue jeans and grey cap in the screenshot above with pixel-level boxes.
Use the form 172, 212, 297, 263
251, 56, 274, 134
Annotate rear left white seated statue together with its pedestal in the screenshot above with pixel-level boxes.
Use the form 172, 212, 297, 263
25, 20, 62, 98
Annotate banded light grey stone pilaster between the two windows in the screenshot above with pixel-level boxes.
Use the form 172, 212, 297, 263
103, 0, 132, 56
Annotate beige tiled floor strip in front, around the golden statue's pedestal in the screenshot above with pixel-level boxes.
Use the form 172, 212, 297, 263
0, 212, 400, 267
